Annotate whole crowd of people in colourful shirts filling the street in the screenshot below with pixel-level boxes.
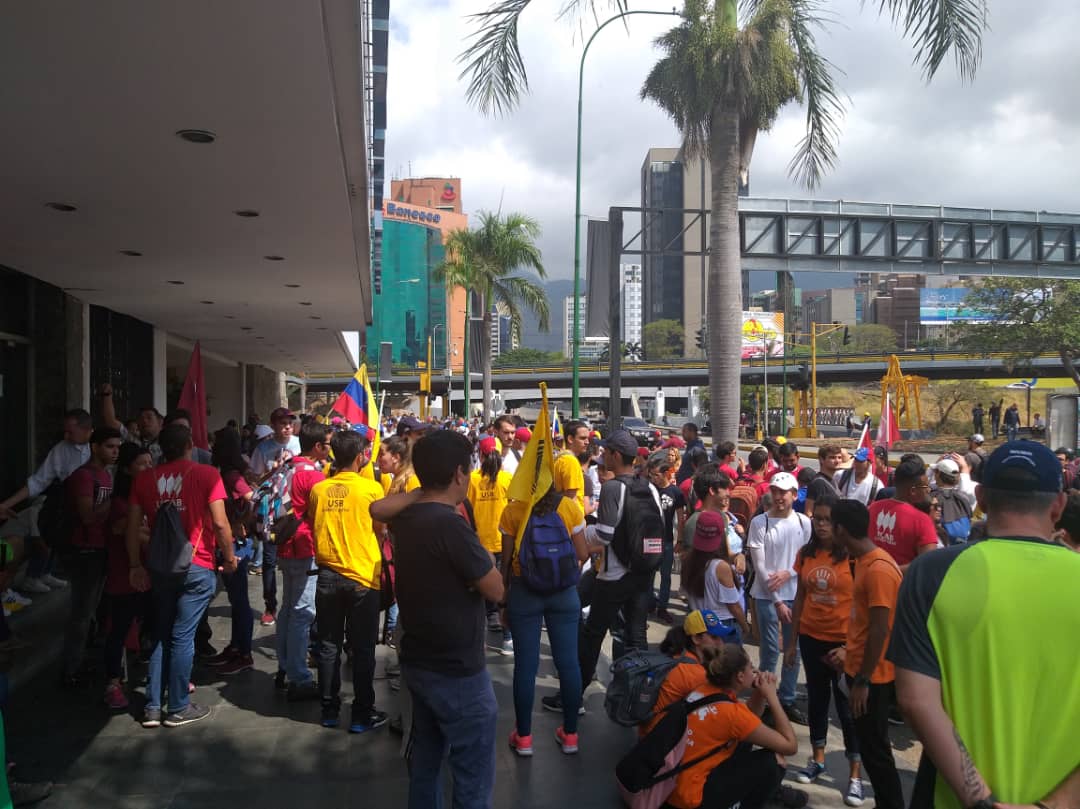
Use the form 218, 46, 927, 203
0, 393, 1080, 809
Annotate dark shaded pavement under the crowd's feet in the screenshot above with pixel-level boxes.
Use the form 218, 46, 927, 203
4, 577, 919, 809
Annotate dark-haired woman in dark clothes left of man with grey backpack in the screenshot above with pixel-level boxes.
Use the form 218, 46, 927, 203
105, 441, 153, 711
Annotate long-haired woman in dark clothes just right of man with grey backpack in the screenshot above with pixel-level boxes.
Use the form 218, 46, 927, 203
206, 427, 255, 674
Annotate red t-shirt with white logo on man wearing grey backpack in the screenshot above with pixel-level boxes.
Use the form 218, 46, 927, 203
131, 459, 225, 570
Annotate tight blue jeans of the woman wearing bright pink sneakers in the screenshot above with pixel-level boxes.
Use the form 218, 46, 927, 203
507, 577, 582, 736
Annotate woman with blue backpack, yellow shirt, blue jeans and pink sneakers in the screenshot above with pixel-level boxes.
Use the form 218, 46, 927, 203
499, 486, 589, 756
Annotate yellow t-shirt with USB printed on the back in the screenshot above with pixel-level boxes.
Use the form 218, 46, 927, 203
308, 472, 382, 590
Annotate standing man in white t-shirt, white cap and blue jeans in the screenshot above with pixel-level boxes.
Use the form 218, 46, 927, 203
746, 472, 810, 725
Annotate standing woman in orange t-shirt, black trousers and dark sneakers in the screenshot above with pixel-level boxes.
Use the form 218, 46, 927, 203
784, 497, 863, 806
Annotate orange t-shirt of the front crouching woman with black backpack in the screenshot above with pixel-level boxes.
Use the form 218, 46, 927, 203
667, 683, 761, 809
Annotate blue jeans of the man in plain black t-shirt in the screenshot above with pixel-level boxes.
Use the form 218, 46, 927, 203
402, 661, 499, 809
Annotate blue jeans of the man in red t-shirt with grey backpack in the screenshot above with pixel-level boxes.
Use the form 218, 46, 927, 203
146, 565, 217, 713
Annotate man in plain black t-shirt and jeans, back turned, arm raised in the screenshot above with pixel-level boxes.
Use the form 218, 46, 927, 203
372, 430, 503, 809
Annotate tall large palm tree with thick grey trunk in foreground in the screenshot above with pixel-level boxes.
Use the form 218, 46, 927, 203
460, 0, 989, 441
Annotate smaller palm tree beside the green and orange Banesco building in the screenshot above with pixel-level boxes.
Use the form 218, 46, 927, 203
434, 212, 550, 420
